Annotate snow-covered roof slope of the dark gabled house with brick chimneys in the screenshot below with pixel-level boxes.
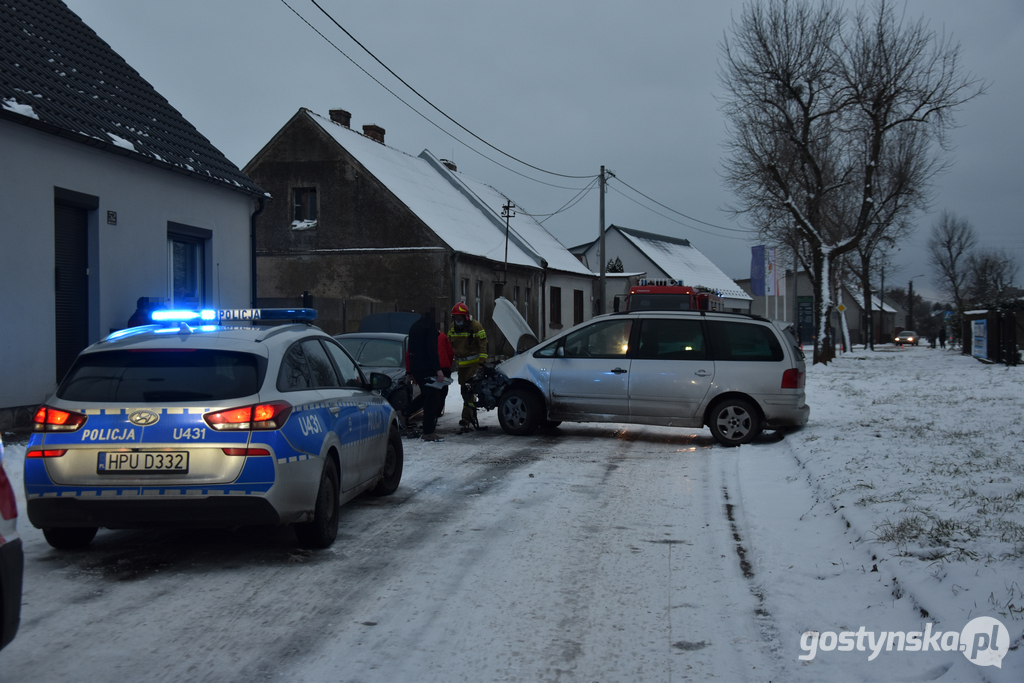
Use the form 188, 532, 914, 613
302, 110, 540, 267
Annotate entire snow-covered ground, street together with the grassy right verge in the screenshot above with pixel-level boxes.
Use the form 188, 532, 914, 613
0, 347, 1024, 683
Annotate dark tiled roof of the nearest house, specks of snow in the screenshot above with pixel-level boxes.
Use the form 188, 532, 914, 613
0, 0, 264, 196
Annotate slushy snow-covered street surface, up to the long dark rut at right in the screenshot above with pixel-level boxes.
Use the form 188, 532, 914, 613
0, 425, 777, 681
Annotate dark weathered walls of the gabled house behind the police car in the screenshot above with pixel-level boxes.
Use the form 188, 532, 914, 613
245, 116, 539, 345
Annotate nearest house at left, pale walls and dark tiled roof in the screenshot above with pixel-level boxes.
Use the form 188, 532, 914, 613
0, 0, 265, 428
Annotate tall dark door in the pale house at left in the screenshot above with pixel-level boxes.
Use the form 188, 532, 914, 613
53, 204, 89, 382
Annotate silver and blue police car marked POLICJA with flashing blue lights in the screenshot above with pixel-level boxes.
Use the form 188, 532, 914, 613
25, 308, 402, 549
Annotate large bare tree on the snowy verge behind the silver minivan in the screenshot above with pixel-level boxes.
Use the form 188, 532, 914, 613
721, 0, 983, 362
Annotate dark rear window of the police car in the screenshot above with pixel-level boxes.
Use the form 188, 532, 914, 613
57, 349, 266, 403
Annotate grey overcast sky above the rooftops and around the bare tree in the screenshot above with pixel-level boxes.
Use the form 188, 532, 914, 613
66, 0, 1024, 296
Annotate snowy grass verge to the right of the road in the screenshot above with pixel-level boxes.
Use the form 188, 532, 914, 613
776, 346, 1024, 681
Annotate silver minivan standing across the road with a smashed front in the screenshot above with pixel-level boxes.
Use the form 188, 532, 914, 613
476, 310, 810, 446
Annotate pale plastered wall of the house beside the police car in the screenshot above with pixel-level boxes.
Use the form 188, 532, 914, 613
0, 120, 254, 409
